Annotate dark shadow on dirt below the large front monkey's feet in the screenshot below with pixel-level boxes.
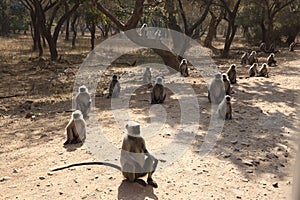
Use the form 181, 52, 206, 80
118, 180, 158, 200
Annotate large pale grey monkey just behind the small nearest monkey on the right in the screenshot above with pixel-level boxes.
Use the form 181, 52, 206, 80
208, 73, 225, 104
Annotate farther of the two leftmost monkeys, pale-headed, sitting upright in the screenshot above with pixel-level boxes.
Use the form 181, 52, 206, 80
75, 85, 92, 119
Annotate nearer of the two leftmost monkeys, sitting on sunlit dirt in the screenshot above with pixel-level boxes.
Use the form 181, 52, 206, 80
64, 110, 86, 145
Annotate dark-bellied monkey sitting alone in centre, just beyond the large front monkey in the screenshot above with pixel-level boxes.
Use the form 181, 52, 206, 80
151, 76, 167, 104
